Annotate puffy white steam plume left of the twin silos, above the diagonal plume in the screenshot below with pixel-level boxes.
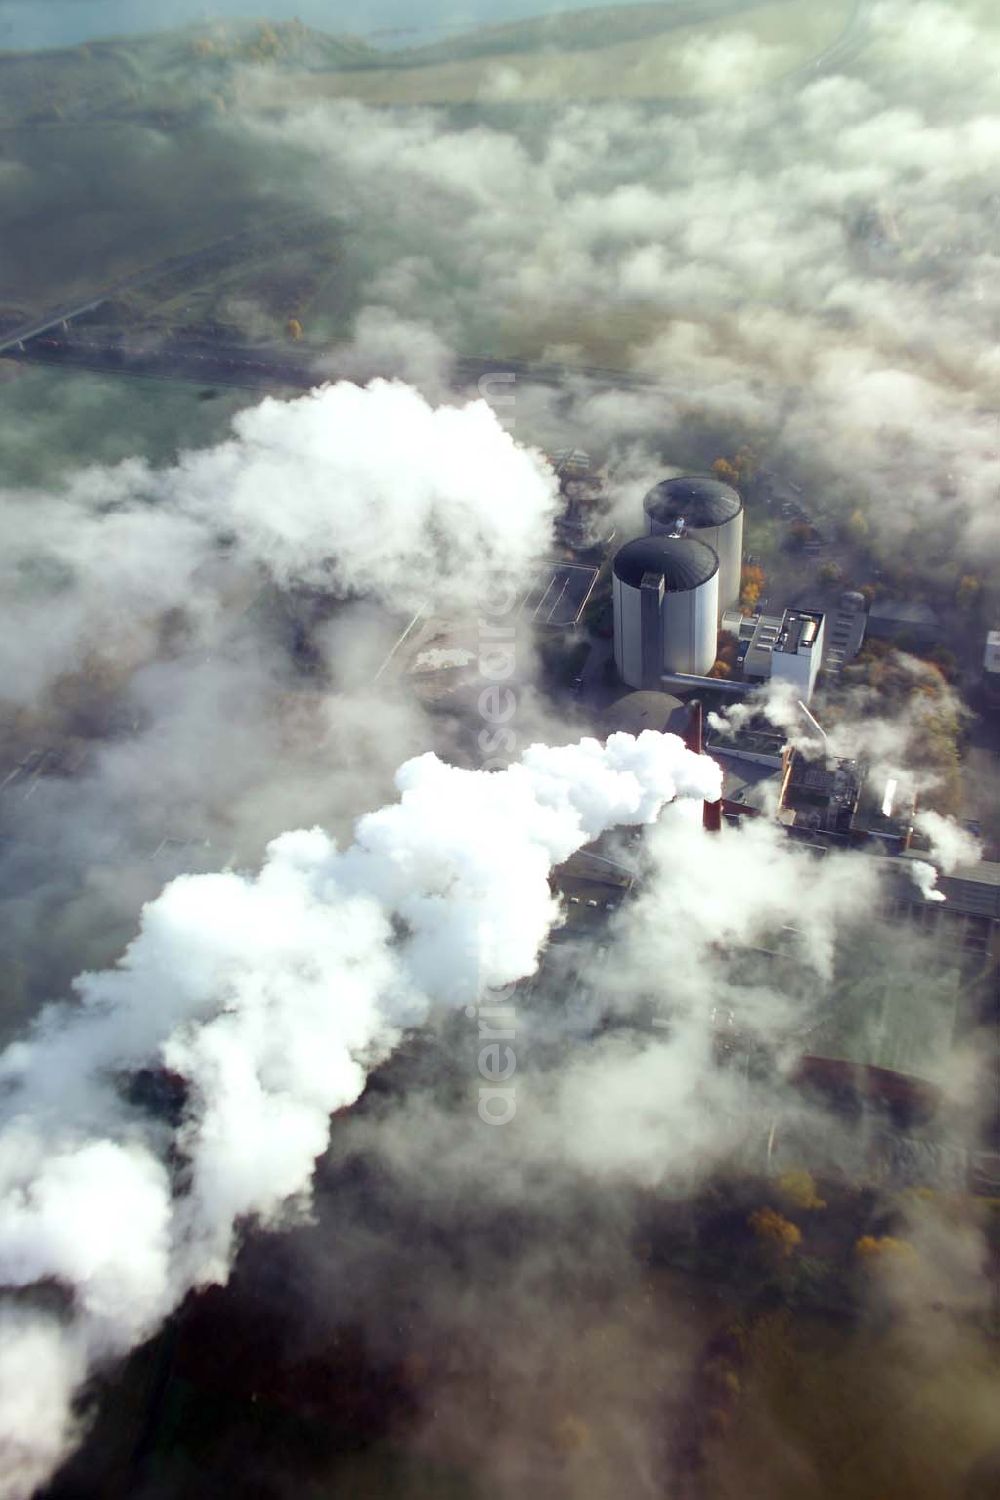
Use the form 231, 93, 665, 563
0, 380, 558, 702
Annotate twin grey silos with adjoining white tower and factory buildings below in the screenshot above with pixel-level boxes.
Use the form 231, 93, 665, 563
606, 476, 947, 854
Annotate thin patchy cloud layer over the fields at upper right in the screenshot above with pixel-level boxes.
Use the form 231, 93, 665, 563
238, 0, 1000, 563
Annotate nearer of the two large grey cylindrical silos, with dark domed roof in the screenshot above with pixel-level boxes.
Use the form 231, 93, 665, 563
612, 536, 718, 689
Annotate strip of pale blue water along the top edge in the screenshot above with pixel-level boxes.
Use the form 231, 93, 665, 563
0, 0, 644, 51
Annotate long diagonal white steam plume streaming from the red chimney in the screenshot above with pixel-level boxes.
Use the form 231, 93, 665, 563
0, 732, 720, 1500
